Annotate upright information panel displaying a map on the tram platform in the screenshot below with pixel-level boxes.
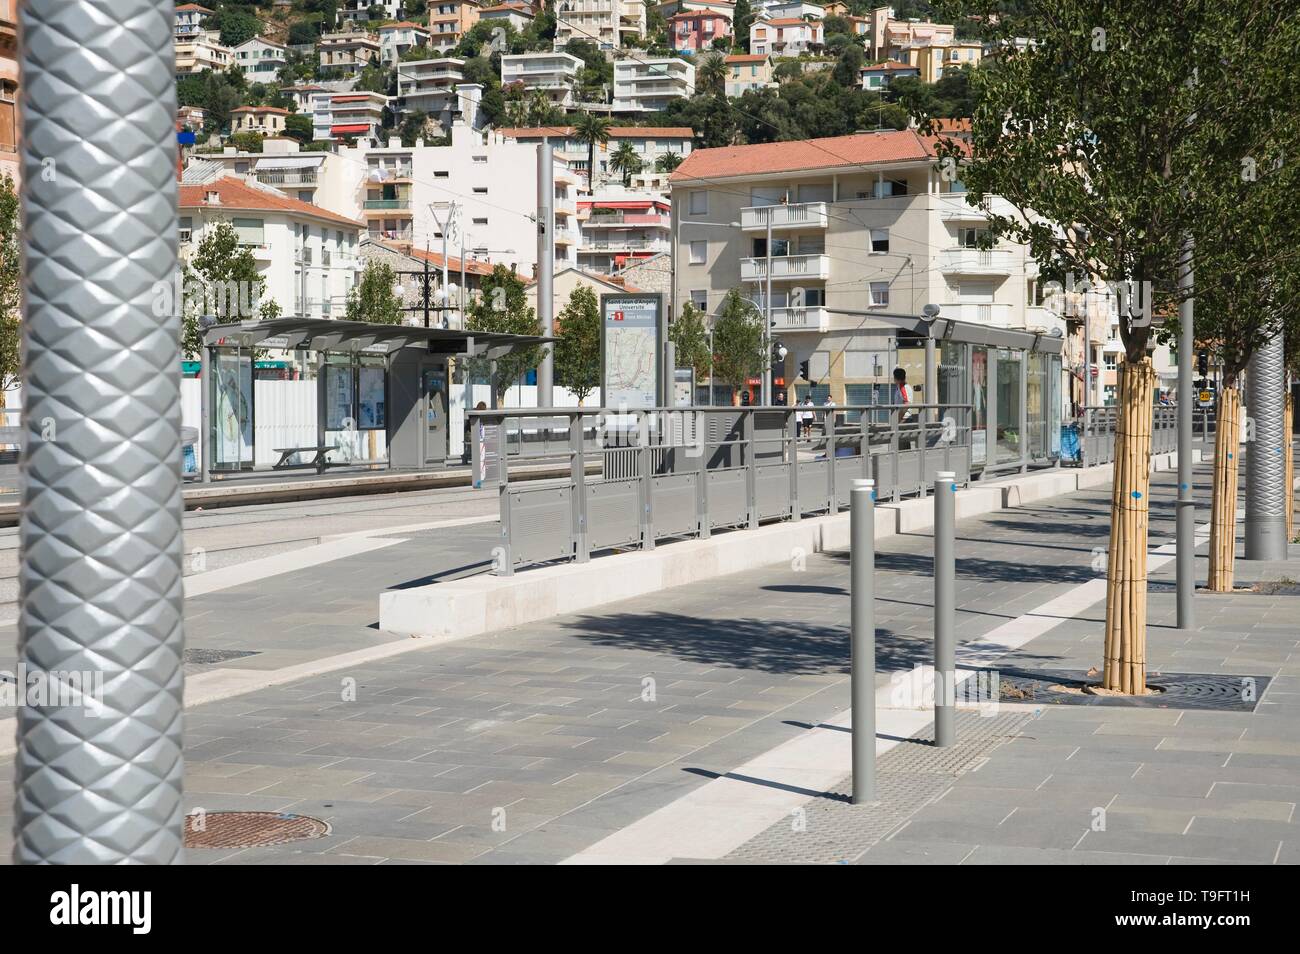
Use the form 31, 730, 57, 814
601, 295, 667, 408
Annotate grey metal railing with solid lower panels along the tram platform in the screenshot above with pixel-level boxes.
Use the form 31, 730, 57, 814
468, 404, 971, 576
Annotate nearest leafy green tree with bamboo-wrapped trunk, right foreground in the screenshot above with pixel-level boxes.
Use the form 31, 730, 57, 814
946, 0, 1297, 694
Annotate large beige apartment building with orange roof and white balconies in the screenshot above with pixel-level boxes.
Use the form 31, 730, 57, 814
671, 130, 1063, 403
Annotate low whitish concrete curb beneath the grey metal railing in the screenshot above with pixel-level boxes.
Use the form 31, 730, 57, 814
380, 454, 1206, 639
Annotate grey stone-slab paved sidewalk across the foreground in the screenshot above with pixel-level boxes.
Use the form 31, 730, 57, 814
0, 457, 1300, 863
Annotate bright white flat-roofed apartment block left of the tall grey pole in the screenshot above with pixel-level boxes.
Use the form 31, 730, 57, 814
339, 121, 580, 277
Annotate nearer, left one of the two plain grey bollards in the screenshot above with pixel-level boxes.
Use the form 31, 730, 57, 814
849, 480, 876, 805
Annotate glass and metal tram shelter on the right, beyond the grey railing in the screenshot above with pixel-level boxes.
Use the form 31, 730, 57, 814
823, 308, 1065, 477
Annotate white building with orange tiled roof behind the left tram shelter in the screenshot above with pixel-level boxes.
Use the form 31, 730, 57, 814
178, 175, 361, 318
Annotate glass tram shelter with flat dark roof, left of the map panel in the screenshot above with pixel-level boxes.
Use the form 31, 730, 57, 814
196, 317, 554, 480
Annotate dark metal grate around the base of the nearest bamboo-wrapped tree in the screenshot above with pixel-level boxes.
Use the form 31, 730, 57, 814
997, 669, 1271, 712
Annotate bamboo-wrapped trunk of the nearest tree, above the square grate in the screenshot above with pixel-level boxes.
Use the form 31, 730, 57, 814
1102, 357, 1156, 695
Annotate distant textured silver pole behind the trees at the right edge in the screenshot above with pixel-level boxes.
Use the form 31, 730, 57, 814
1245, 331, 1290, 560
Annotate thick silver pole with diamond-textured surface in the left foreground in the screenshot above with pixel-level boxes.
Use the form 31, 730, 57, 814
13, 0, 182, 864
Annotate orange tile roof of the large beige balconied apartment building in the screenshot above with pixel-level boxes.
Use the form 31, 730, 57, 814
670, 129, 935, 185
